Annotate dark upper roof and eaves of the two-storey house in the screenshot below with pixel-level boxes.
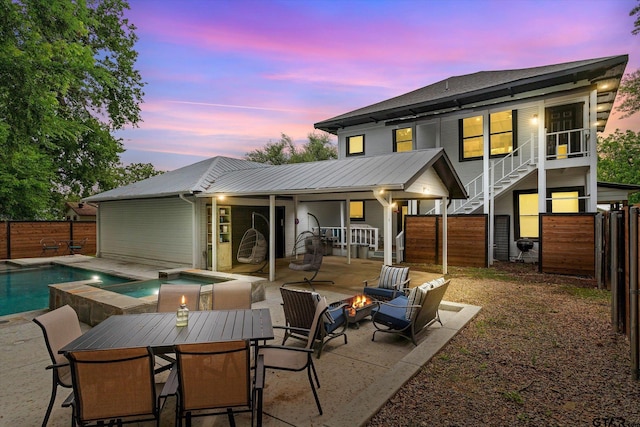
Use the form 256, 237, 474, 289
314, 55, 629, 134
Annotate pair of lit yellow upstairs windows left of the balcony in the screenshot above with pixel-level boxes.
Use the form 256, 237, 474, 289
460, 110, 516, 161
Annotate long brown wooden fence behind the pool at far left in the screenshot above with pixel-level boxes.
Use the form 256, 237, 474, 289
0, 221, 96, 259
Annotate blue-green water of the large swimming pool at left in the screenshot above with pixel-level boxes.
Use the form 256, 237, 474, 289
0, 264, 131, 316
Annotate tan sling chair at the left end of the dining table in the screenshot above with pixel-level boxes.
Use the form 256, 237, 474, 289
33, 305, 82, 427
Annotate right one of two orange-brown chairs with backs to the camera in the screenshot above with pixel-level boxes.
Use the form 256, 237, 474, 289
170, 341, 264, 426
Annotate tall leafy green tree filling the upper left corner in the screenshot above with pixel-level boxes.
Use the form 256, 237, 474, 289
0, 0, 143, 219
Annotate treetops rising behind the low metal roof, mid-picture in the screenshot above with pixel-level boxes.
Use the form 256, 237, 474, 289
244, 132, 338, 165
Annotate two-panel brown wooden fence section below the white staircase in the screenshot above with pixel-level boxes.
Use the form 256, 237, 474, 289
404, 215, 489, 267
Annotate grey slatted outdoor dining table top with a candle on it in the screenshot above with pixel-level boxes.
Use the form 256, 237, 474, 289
60, 308, 274, 354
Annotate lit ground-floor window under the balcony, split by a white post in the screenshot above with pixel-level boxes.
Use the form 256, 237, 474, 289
514, 187, 585, 239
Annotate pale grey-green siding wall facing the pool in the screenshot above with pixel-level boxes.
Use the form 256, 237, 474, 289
98, 197, 193, 267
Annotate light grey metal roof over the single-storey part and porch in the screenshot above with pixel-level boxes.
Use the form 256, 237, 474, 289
85, 148, 467, 202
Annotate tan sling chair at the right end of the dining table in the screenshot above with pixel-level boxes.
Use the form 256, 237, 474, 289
258, 299, 327, 415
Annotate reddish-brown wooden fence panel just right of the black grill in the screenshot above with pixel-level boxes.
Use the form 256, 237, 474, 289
540, 213, 596, 277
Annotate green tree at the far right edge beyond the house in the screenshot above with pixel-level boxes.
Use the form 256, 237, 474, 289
598, 130, 640, 204
